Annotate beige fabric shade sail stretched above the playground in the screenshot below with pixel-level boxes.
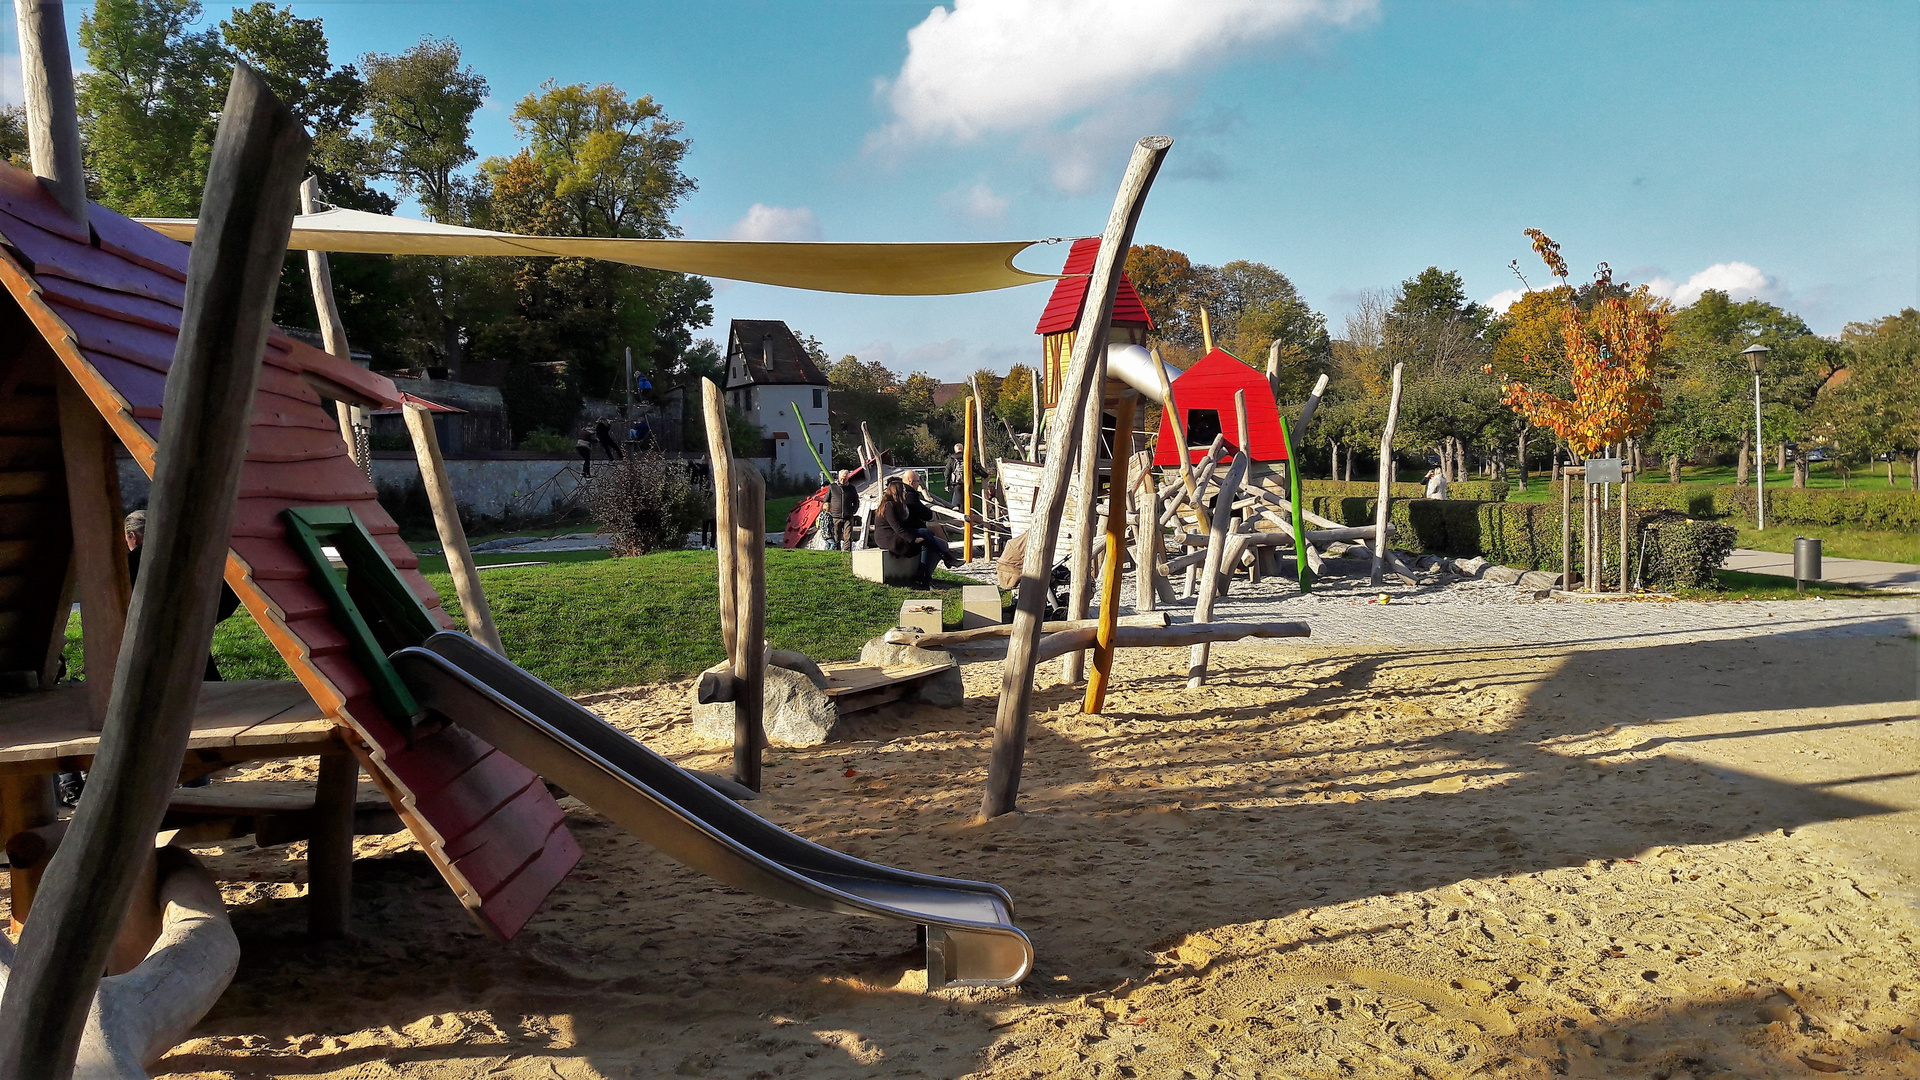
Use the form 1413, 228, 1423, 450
140, 208, 1058, 296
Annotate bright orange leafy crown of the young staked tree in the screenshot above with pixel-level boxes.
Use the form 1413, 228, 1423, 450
1501, 229, 1672, 457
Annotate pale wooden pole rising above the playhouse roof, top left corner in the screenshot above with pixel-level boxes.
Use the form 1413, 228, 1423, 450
13, 0, 86, 231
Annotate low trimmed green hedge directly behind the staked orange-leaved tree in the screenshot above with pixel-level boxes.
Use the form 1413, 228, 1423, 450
1302, 492, 1734, 588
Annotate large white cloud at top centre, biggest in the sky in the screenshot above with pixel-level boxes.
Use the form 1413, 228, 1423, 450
877, 0, 1379, 142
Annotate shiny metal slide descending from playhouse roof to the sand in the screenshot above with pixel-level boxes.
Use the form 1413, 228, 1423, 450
390, 630, 1033, 990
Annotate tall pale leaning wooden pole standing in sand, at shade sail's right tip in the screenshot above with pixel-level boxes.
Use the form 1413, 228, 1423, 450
979, 135, 1173, 819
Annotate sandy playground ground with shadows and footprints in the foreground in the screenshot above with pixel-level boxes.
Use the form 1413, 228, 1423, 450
7, 636, 1920, 1080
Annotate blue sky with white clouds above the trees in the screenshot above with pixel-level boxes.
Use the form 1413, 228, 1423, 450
0, 0, 1920, 377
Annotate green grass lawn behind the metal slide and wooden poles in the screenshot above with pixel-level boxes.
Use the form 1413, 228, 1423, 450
67, 550, 970, 694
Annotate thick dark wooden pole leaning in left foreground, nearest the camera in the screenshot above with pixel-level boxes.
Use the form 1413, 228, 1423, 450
0, 63, 311, 1080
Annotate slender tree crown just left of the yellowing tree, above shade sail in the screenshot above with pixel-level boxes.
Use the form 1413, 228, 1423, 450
361, 38, 488, 221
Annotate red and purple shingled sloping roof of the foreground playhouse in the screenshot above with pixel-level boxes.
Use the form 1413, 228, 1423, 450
0, 163, 580, 938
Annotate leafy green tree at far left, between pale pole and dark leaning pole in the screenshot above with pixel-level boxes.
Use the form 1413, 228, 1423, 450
73, 0, 230, 217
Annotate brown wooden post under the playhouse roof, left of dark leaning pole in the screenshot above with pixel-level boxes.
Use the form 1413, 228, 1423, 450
54, 367, 132, 730
